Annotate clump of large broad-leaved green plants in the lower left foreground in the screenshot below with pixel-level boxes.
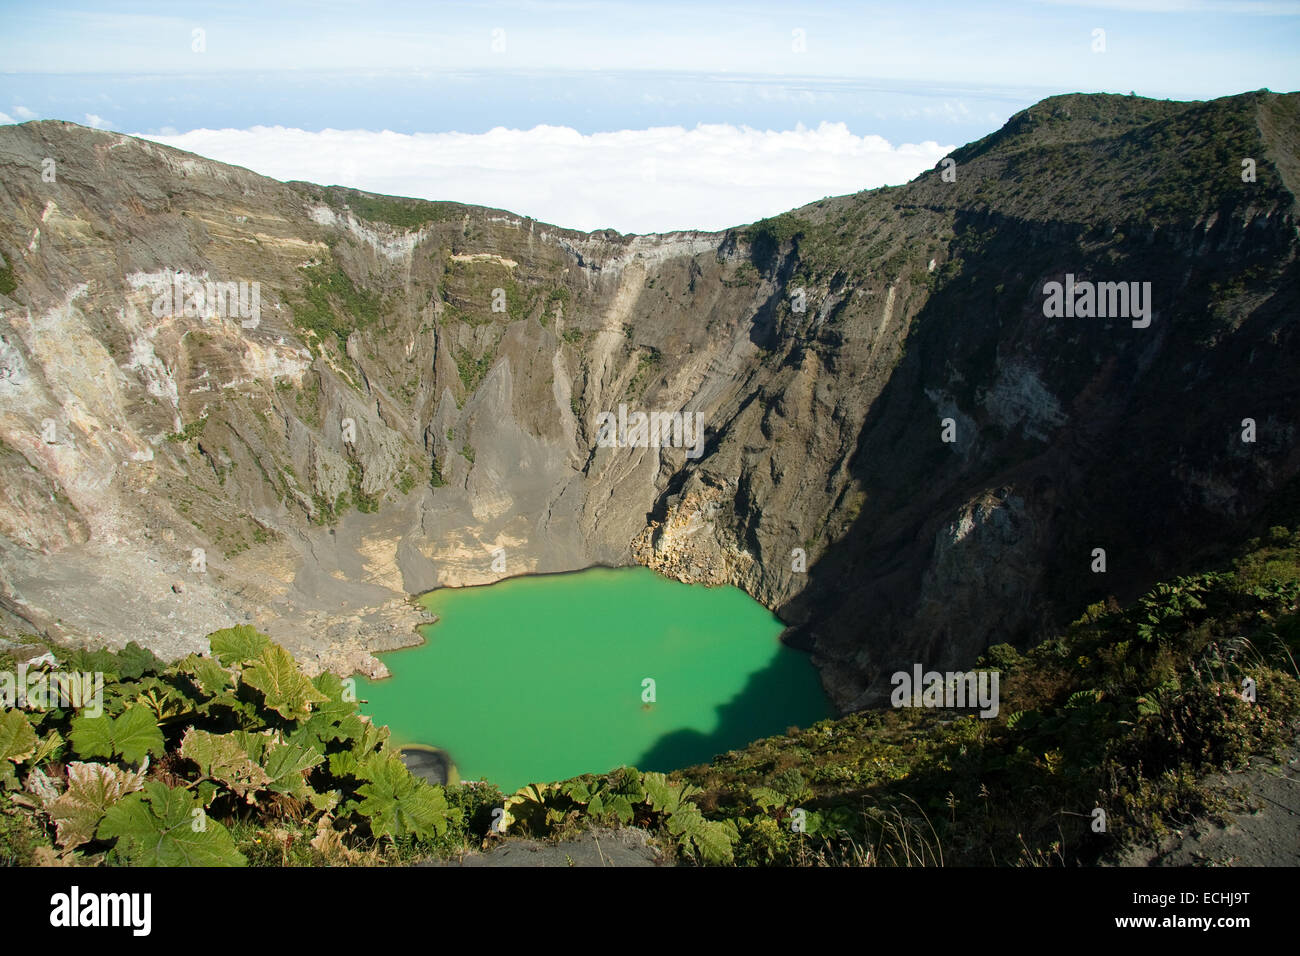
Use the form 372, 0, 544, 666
0, 626, 463, 866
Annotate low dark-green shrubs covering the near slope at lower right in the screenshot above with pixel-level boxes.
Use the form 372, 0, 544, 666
660, 528, 1300, 865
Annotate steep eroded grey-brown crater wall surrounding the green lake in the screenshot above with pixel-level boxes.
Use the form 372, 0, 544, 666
0, 94, 1300, 709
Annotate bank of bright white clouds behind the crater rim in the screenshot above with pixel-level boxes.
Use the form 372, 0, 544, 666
137, 122, 954, 233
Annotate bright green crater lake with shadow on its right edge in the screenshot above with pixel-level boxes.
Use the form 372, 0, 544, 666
359, 567, 831, 792
